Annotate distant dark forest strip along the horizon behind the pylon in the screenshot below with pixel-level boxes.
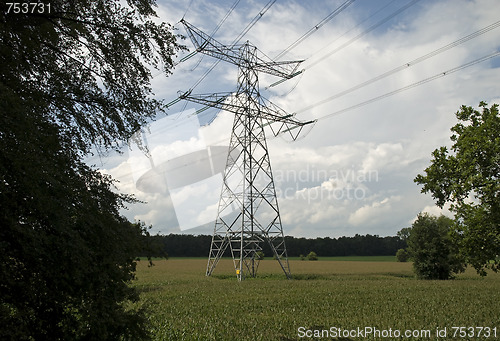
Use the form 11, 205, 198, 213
144, 234, 406, 257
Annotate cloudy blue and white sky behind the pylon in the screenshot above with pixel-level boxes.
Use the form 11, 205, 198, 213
89, 0, 500, 238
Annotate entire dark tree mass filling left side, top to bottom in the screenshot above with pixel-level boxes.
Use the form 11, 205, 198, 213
0, 0, 184, 340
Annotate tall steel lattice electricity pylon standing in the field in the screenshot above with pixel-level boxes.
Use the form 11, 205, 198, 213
180, 19, 314, 281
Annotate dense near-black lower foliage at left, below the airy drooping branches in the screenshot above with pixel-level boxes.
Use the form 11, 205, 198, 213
0, 108, 152, 340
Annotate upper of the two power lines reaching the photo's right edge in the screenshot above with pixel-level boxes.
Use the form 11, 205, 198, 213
296, 21, 500, 113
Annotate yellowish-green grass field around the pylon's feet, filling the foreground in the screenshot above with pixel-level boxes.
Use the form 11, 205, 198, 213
133, 259, 500, 340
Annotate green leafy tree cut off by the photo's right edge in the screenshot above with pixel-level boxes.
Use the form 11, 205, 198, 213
415, 102, 500, 275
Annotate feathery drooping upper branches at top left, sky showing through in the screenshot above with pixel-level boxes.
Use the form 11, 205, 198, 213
0, 0, 182, 152
